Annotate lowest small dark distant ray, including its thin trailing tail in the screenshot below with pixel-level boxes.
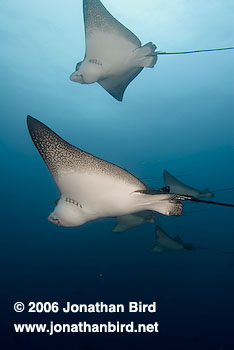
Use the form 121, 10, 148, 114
152, 225, 234, 255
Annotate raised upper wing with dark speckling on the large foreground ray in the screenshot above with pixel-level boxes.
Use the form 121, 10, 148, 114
27, 116, 144, 192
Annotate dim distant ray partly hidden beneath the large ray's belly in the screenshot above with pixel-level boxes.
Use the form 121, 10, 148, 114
113, 211, 160, 232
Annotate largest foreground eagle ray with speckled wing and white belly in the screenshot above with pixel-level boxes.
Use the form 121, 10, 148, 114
27, 116, 185, 226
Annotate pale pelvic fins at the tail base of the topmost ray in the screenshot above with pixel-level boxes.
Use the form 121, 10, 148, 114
134, 42, 158, 68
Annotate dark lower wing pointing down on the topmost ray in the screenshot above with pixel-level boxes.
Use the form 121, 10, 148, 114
98, 67, 143, 101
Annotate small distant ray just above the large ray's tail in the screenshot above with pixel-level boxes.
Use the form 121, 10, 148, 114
163, 170, 214, 198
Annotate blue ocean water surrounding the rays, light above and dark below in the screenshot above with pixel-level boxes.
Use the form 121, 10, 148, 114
0, 0, 234, 350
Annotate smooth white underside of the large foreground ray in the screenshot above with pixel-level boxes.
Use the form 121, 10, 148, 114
49, 171, 178, 226
